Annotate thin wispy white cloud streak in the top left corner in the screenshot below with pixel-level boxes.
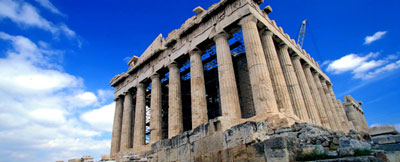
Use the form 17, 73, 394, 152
0, 0, 75, 37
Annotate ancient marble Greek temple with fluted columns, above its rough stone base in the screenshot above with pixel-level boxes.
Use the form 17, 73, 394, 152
110, 0, 368, 157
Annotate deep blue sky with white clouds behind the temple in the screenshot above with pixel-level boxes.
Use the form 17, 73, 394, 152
0, 0, 400, 162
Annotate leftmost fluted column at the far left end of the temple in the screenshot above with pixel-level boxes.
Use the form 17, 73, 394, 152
110, 97, 123, 157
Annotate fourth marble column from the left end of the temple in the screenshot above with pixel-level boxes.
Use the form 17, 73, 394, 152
149, 74, 162, 144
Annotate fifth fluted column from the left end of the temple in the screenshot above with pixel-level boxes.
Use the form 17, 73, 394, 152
168, 63, 183, 138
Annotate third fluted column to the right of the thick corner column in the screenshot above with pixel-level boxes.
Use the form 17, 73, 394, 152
292, 55, 321, 125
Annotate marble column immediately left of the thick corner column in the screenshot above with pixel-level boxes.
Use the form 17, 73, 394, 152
214, 33, 241, 121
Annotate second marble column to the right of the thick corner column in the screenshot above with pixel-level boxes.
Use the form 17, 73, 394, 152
278, 44, 310, 122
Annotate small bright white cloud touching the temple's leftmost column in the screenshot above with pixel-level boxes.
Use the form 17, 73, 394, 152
81, 103, 115, 132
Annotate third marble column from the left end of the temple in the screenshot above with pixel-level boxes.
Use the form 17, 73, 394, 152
133, 83, 146, 150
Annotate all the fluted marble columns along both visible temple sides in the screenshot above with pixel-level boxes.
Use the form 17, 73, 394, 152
111, 16, 345, 155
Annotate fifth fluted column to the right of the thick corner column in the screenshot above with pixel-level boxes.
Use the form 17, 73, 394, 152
313, 72, 337, 130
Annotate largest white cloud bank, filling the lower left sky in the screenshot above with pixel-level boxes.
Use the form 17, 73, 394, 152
0, 32, 113, 162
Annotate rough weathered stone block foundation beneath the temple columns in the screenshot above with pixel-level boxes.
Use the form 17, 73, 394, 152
119, 120, 381, 162
